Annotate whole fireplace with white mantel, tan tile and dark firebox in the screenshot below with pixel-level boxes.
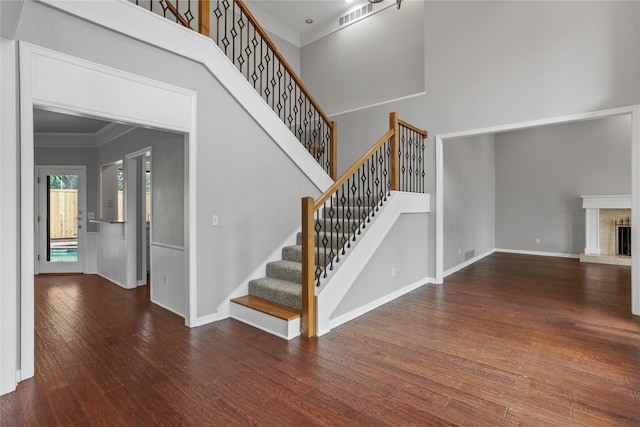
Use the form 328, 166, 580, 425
580, 196, 631, 265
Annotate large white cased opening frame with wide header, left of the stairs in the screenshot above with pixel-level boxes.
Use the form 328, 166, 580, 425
16, 41, 197, 381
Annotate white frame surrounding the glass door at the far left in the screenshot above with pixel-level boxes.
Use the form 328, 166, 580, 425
34, 165, 88, 274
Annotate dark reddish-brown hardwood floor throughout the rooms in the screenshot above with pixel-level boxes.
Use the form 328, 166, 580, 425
0, 254, 640, 426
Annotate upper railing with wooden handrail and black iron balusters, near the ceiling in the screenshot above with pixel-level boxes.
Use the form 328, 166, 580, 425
134, 0, 337, 179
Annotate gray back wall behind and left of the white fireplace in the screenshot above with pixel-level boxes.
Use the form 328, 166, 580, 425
496, 116, 631, 254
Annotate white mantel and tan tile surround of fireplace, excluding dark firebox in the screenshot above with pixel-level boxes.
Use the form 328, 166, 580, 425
580, 195, 631, 265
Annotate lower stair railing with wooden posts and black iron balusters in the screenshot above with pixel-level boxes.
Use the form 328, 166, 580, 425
302, 113, 427, 336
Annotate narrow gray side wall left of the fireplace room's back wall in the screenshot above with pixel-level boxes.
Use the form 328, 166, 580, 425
443, 135, 496, 271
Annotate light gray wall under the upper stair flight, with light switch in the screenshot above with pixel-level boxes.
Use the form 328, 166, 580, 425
16, 2, 319, 316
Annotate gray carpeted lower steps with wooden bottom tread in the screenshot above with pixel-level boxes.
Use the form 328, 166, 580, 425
231, 200, 369, 339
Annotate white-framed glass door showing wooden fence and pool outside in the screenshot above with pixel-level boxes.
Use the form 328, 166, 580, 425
36, 167, 85, 273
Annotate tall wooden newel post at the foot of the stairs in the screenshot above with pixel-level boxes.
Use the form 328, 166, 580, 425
302, 197, 316, 337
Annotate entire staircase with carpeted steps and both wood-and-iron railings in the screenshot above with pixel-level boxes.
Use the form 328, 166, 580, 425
130, 0, 427, 339
